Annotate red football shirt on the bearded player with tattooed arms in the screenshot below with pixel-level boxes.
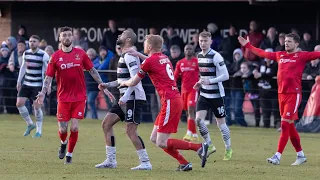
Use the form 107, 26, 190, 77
46, 48, 93, 102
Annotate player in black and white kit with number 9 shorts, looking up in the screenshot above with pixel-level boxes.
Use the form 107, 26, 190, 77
95, 29, 152, 170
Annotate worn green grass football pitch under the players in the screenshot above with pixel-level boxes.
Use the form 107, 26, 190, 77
0, 115, 320, 180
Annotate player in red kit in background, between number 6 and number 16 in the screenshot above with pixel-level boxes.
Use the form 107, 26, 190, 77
174, 44, 199, 141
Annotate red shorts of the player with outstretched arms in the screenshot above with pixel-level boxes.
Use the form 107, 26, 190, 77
278, 94, 301, 120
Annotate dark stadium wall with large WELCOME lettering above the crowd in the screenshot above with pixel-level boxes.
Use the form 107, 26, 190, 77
0, 2, 320, 48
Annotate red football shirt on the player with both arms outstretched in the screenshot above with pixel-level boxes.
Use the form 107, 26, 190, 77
245, 43, 320, 93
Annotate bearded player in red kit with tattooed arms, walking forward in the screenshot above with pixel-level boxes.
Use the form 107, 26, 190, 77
36, 27, 112, 164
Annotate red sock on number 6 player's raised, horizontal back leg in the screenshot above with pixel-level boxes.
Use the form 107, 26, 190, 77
167, 139, 202, 151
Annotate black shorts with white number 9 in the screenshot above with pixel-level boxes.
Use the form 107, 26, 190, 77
109, 100, 146, 124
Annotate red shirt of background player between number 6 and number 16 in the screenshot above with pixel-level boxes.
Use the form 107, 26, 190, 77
174, 57, 199, 93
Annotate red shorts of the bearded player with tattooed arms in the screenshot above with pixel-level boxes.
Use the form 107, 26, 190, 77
57, 101, 86, 122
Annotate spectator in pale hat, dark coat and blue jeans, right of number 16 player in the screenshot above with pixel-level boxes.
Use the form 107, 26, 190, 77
227, 48, 248, 127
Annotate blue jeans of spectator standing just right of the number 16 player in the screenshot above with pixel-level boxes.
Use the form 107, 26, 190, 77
231, 90, 248, 126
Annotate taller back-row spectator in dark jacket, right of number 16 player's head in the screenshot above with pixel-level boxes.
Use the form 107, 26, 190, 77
219, 25, 242, 68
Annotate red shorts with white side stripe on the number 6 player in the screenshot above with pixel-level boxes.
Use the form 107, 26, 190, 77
154, 98, 183, 133
